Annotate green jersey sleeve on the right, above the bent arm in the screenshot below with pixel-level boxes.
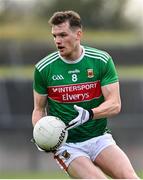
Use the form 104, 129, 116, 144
101, 57, 119, 86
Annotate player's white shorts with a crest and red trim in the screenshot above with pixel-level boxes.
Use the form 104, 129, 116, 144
54, 133, 116, 171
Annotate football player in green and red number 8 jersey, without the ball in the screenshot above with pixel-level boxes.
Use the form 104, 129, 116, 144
32, 11, 138, 179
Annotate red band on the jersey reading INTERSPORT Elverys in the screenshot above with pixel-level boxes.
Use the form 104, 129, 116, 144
48, 81, 101, 103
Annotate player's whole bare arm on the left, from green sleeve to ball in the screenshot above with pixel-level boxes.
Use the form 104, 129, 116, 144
32, 91, 47, 126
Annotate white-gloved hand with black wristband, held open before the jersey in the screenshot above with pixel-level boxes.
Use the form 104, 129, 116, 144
66, 105, 93, 130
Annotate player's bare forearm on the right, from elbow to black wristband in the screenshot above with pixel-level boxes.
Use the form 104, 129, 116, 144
92, 100, 121, 119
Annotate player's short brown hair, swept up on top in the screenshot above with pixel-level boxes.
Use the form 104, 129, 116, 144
49, 11, 82, 28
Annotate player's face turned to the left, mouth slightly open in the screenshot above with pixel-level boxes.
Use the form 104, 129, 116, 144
52, 22, 81, 60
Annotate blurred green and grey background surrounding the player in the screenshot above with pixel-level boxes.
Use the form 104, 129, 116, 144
0, 0, 143, 179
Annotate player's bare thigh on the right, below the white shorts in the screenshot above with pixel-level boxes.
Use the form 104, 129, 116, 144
94, 145, 137, 179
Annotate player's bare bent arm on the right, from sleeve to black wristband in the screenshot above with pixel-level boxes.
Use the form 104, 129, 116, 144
92, 82, 121, 119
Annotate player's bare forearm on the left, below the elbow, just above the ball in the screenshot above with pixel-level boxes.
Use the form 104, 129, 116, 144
32, 109, 47, 126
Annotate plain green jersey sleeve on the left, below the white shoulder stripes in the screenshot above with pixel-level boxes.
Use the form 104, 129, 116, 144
33, 68, 47, 95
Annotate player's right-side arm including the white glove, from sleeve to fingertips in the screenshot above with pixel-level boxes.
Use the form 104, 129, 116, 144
68, 82, 121, 129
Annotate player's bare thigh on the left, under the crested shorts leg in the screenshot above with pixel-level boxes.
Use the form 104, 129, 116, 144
67, 156, 106, 179
